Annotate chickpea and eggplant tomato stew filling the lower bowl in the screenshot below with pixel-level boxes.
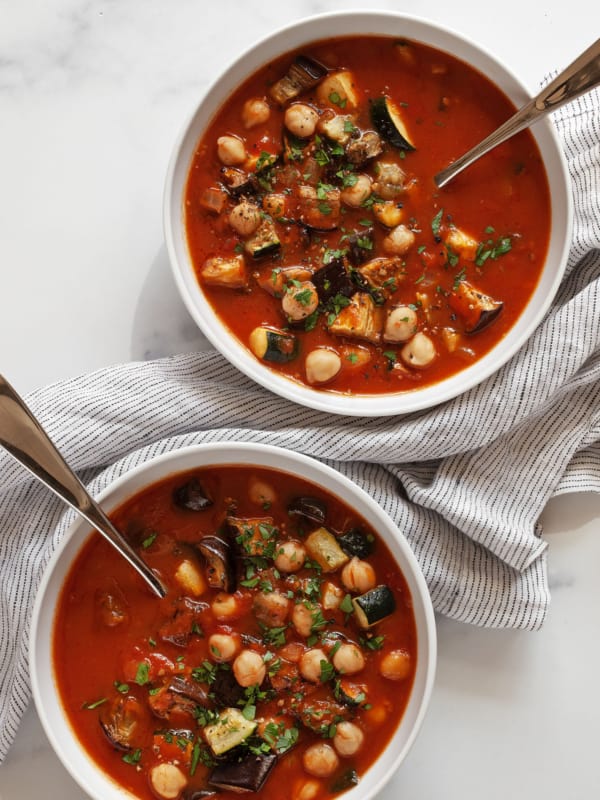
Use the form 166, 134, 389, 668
53, 465, 417, 800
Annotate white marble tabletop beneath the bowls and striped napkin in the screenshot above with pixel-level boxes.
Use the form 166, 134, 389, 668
0, 0, 600, 800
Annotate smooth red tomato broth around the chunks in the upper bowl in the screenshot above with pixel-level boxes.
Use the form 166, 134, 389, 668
185, 36, 550, 394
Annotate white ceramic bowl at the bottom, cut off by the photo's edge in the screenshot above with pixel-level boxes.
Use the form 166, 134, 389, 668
30, 442, 436, 800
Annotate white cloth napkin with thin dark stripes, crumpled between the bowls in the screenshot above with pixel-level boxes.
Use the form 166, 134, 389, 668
0, 92, 600, 761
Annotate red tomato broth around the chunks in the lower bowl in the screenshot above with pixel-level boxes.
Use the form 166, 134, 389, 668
53, 466, 417, 800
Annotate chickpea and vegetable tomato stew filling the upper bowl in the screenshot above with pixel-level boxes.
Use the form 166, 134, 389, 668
184, 36, 550, 394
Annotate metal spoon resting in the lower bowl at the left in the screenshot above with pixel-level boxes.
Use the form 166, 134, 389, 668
0, 375, 167, 597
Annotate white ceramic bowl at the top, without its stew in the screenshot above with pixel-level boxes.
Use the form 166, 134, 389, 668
164, 11, 572, 416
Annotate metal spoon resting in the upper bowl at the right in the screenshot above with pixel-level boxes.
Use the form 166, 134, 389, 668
433, 39, 600, 189
